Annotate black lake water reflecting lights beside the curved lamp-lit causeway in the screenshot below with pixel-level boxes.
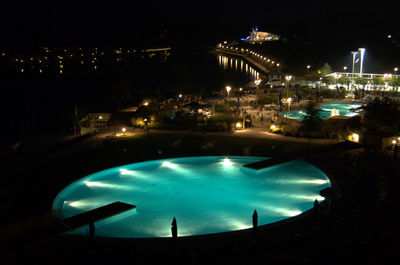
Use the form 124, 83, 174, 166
0, 50, 259, 141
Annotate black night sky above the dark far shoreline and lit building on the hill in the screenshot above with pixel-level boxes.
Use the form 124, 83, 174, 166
0, 0, 400, 42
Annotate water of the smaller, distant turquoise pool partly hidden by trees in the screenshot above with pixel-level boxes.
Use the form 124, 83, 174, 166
281, 103, 361, 120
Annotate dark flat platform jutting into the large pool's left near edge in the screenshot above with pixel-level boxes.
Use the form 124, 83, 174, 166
60, 201, 136, 234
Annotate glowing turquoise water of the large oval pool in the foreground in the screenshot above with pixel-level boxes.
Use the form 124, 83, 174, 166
53, 156, 330, 238
